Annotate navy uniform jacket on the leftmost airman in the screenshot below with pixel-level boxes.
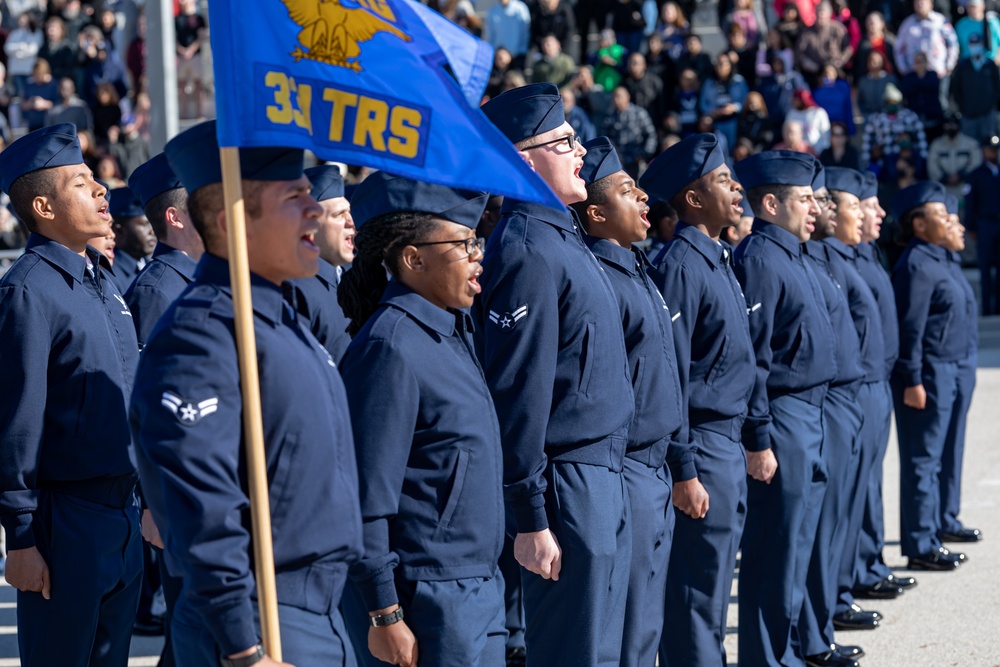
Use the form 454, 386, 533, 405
0, 234, 139, 552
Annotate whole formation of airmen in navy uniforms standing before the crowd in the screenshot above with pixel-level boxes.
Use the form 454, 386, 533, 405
0, 78, 980, 667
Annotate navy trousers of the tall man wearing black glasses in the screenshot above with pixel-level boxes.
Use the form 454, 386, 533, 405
521, 461, 632, 667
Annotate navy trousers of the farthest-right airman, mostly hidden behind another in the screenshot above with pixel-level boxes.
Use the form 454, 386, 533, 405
940, 354, 978, 533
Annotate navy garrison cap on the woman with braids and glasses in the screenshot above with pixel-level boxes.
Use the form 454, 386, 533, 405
351, 171, 489, 229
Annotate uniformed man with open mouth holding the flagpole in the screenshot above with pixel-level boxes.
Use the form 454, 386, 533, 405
130, 121, 361, 667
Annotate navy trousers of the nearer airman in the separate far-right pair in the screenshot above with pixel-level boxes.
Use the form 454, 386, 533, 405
892, 361, 959, 557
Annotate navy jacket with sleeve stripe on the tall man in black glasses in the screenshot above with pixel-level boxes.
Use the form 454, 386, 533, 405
474, 201, 634, 532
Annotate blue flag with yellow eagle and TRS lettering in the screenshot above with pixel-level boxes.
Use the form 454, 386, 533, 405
208, 0, 562, 208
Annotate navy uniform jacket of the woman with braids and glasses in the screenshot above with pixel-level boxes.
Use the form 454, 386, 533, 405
340, 282, 503, 610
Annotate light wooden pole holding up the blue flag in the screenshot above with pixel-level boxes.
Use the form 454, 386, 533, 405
219, 148, 281, 662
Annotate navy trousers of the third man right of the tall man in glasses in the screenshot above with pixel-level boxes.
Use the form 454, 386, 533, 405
739, 395, 827, 667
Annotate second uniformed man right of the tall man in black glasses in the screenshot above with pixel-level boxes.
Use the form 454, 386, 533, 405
633, 134, 756, 667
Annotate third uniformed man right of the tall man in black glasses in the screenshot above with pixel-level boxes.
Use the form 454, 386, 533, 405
736, 151, 837, 665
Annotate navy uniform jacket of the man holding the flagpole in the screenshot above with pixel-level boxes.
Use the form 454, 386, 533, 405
130, 253, 361, 655
